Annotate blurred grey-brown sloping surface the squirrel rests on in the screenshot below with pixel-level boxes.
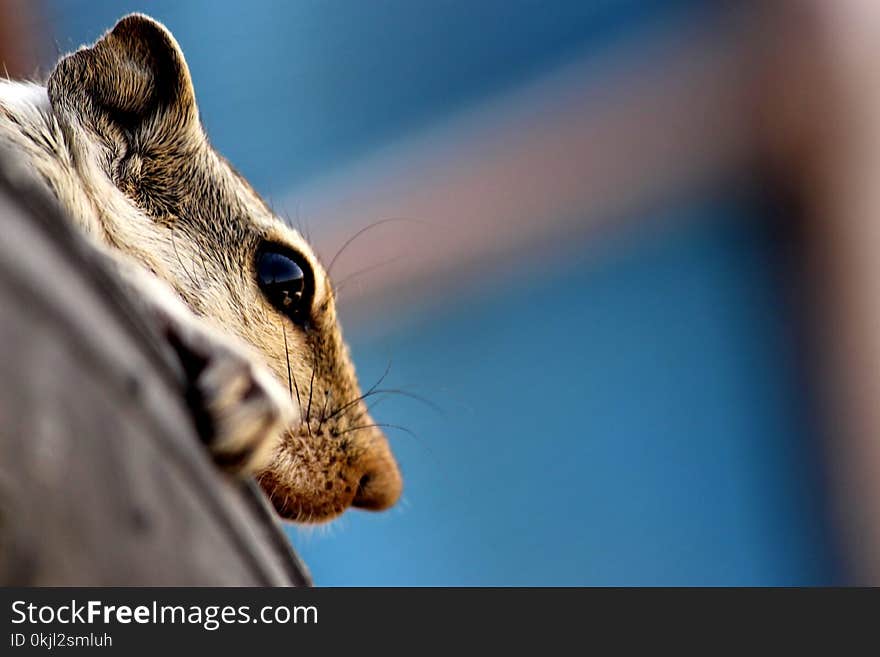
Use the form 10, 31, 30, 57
0, 151, 311, 586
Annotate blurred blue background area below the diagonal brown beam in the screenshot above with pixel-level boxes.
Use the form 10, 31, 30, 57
324, 196, 838, 586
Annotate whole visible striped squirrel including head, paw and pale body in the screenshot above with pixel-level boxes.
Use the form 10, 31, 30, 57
0, 14, 402, 522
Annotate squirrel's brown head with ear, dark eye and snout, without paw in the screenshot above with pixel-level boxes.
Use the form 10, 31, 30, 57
48, 15, 401, 522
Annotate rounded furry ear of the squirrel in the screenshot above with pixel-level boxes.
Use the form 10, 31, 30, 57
47, 14, 198, 141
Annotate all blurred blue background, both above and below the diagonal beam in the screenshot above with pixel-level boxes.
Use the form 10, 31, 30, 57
45, 0, 844, 585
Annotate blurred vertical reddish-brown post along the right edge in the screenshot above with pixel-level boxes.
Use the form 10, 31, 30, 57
765, 0, 880, 586
